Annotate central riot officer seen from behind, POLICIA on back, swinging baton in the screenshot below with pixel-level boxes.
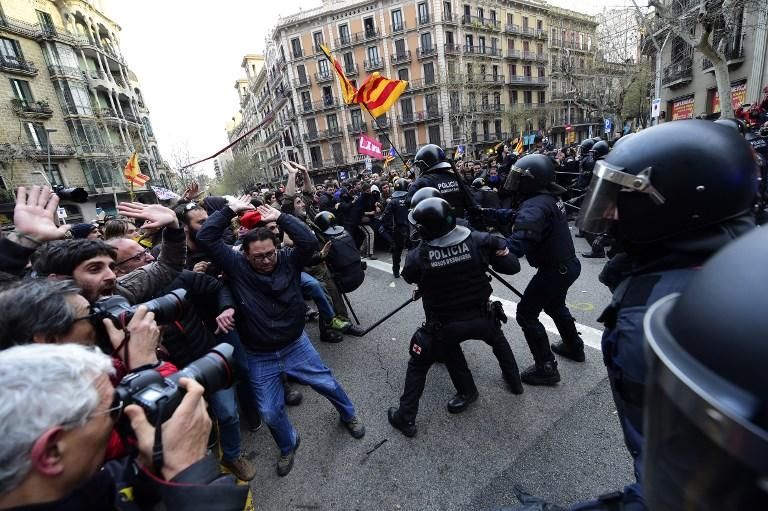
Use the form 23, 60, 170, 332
388, 198, 523, 437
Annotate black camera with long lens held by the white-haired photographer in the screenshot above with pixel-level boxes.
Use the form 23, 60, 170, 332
115, 343, 234, 427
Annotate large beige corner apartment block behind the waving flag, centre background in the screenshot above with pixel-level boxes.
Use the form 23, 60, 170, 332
225, 0, 594, 177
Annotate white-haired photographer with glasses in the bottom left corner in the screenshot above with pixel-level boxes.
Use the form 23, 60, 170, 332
0, 344, 248, 511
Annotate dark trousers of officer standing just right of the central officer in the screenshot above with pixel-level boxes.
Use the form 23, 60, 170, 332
515, 257, 581, 364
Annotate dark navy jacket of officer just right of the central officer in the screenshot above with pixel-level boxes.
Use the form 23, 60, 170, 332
512, 194, 576, 268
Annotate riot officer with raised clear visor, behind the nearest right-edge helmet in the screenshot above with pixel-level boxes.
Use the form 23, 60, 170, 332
577, 120, 756, 503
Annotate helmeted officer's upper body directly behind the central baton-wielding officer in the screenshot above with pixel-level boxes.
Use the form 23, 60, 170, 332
408, 144, 478, 218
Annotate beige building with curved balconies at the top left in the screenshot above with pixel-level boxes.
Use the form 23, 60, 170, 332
0, 0, 174, 225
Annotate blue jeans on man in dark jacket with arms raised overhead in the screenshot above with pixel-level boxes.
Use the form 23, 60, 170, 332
247, 332, 355, 454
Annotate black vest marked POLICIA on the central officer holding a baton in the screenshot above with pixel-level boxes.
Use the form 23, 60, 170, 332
418, 234, 492, 318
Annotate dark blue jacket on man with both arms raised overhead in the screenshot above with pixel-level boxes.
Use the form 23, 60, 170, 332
197, 207, 318, 353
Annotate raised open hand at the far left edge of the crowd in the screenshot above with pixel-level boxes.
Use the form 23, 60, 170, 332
13, 185, 69, 242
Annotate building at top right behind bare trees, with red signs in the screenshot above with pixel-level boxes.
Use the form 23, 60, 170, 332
656, 0, 768, 121
